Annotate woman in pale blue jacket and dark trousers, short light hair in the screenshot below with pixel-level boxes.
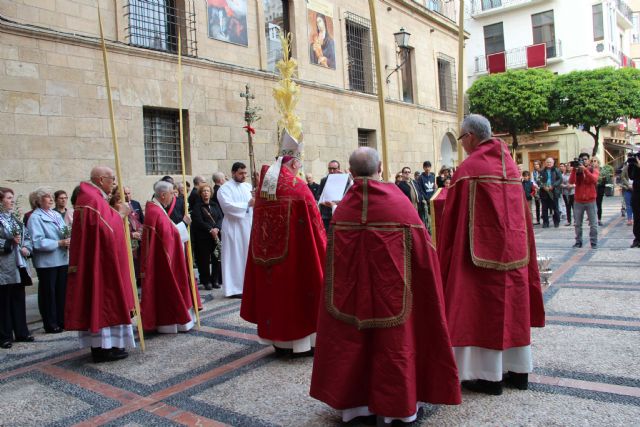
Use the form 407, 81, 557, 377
28, 188, 71, 334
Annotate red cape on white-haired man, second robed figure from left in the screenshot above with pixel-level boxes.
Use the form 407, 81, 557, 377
140, 202, 193, 330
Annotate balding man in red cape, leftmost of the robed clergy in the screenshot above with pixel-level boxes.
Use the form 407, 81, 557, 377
64, 166, 135, 362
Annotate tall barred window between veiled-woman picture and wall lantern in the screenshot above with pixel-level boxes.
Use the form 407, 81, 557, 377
345, 12, 376, 94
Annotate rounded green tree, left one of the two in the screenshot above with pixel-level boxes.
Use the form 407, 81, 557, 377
467, 69, 555, 150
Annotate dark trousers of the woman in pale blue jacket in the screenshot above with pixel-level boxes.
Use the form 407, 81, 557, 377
36, 265, 68, 331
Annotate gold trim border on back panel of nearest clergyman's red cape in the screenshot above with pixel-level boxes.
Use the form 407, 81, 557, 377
325, 225, 413, 329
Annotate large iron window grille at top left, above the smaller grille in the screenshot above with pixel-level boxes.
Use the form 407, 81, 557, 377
124, 0, 198, 56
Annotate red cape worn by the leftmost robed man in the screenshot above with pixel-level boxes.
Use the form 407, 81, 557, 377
64, 182, 134, 333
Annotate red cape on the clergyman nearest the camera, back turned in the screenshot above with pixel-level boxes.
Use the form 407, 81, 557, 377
310, 178, 460, 418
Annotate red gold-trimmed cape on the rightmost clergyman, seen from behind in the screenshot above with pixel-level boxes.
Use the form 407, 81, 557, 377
438, 139, 544, 350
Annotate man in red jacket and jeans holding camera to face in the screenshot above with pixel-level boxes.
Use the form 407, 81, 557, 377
569, 153, 600, 249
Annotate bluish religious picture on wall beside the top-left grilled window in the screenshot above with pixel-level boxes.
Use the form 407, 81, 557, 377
207, 0, 249, 46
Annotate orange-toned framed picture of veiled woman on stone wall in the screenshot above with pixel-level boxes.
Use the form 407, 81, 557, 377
307, 0, 336, 70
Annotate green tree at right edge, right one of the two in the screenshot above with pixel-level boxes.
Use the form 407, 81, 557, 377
551, 67, 640, 156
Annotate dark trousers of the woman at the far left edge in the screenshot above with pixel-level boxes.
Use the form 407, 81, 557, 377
0, 284, 29, 342
